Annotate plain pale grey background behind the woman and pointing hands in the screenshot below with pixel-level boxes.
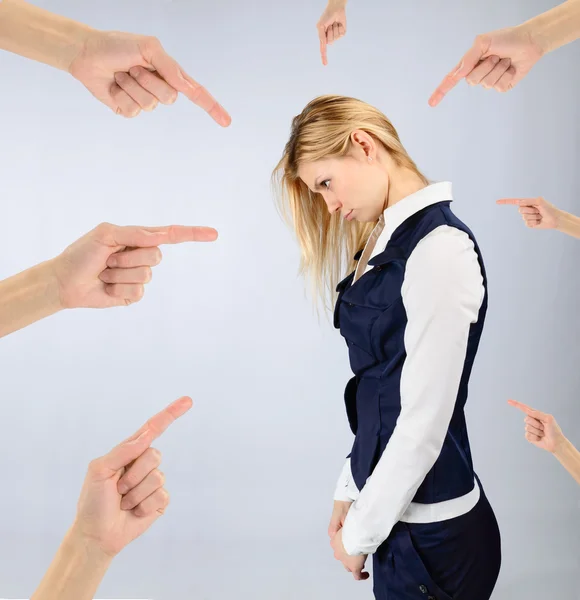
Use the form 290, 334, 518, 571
0, 0, 580, 600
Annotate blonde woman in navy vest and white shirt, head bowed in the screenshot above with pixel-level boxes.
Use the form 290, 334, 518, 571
275, 96, 501, 600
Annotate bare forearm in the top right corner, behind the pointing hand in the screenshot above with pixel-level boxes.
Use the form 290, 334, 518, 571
522, 0, 580, 52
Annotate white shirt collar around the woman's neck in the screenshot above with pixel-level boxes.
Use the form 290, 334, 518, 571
371, 181, 453, 258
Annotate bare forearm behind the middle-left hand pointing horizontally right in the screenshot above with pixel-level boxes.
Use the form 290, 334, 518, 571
0, 261, 62, 338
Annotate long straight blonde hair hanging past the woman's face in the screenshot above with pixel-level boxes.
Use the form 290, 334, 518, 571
272, 95, 428, 308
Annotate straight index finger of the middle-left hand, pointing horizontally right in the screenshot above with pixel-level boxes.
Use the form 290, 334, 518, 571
110, 225, 217, 248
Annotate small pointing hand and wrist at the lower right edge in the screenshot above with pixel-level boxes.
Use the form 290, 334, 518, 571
508, 400, 580, 483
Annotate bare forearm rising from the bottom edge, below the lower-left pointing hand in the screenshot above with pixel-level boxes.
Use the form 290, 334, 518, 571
30, 529, 112, 600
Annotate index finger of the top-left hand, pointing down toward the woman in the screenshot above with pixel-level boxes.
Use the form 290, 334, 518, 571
143, 41, 232, 127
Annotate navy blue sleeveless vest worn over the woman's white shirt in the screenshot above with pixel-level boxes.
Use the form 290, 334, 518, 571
334, 201, 487, 504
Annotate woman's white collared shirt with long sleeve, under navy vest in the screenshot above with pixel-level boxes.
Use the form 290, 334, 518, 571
334, 182, 485, 555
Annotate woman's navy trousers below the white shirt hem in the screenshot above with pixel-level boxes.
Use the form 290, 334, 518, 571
373, 485, 501, 600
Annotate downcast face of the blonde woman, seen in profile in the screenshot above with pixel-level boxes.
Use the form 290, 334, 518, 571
298, 148, 389, 223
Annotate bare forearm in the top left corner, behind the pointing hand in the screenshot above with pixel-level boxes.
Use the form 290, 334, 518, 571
0, 0, 92, 71
